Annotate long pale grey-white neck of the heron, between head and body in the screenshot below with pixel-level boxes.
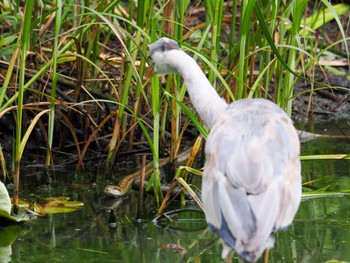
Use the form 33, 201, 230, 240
176, 51, 228, 129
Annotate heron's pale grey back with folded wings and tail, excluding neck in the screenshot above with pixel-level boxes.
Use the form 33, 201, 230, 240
202, 99, 301, 258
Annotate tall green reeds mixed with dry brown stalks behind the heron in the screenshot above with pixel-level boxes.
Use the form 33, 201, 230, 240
0, 0, 349, 210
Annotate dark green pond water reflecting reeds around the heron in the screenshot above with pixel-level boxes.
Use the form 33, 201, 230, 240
0, 120, 350, 263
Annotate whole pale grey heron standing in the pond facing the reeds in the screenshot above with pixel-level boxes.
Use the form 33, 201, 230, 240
149, 38, 301, 262
